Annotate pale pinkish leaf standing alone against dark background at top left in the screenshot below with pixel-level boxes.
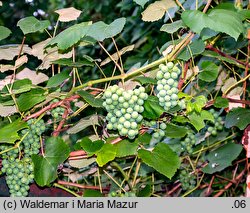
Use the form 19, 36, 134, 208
55, 7, 82, 22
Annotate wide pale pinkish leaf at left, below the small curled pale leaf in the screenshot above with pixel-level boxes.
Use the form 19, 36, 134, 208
16, 68, 49, 85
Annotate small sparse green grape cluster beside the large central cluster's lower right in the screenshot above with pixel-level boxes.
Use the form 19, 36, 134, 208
143, 120, 167, 139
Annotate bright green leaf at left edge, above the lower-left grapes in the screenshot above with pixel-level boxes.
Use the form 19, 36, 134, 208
0, 120, 28, 144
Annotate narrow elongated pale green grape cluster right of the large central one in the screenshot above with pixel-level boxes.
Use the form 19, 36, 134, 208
156, 62, 183, 111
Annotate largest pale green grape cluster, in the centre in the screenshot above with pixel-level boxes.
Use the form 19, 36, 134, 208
103, 85, 148, 139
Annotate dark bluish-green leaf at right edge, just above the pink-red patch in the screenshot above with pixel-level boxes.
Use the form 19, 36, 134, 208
225, 108, 250, 130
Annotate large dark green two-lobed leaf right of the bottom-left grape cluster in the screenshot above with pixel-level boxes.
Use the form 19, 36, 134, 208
31, 137, 70, 186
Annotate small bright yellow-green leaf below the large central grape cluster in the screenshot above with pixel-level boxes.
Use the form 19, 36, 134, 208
96, 143, 116, 167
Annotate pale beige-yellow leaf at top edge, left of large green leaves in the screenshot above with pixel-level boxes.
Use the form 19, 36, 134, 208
142, 0, 176, 22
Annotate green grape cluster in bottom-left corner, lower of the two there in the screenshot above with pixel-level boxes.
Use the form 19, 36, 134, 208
2, 156, 34, 197
